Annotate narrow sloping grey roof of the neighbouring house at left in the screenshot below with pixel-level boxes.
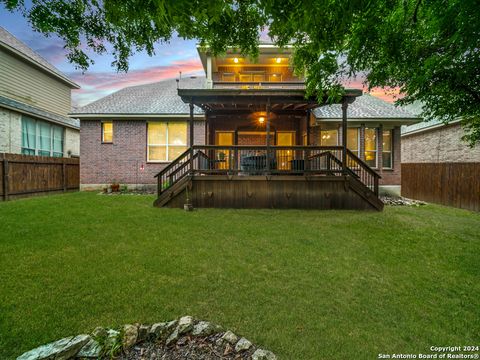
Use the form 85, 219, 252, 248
0, 26, 80, 89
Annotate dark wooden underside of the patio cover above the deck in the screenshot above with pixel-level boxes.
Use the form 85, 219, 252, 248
178, 89, 362, 112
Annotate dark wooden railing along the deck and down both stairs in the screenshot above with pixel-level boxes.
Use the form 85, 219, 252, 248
156, 145, 380, 196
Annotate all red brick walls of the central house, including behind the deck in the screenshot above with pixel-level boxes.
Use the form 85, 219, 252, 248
80, 116, 401, 188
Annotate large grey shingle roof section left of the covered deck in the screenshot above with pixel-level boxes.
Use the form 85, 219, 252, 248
73, 77, 205, 117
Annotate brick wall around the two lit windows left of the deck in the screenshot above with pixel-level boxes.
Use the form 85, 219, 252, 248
80, 120, 205, 188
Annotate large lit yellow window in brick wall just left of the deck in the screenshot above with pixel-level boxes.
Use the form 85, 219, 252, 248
147, 122, 187, 161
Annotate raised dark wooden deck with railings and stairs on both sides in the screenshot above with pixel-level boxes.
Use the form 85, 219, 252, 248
155, 145, 383, 210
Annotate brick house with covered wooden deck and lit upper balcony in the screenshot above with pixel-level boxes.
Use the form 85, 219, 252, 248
72, 44, 419, 208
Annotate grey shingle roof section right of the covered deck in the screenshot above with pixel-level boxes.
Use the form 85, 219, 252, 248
313, 94, 419, 120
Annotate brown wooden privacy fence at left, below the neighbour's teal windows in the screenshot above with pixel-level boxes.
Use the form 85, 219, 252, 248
0, 154, 80, 200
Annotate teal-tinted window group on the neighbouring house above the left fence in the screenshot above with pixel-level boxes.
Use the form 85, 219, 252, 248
22, 116, 64, 157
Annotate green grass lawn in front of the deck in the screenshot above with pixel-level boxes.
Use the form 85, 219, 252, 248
0, 193, 480, 359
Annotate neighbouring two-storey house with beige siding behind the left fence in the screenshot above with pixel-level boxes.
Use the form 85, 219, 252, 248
0, 27, 80, 157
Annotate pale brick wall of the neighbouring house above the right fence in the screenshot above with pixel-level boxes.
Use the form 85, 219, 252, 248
402, 123, 480, 163
